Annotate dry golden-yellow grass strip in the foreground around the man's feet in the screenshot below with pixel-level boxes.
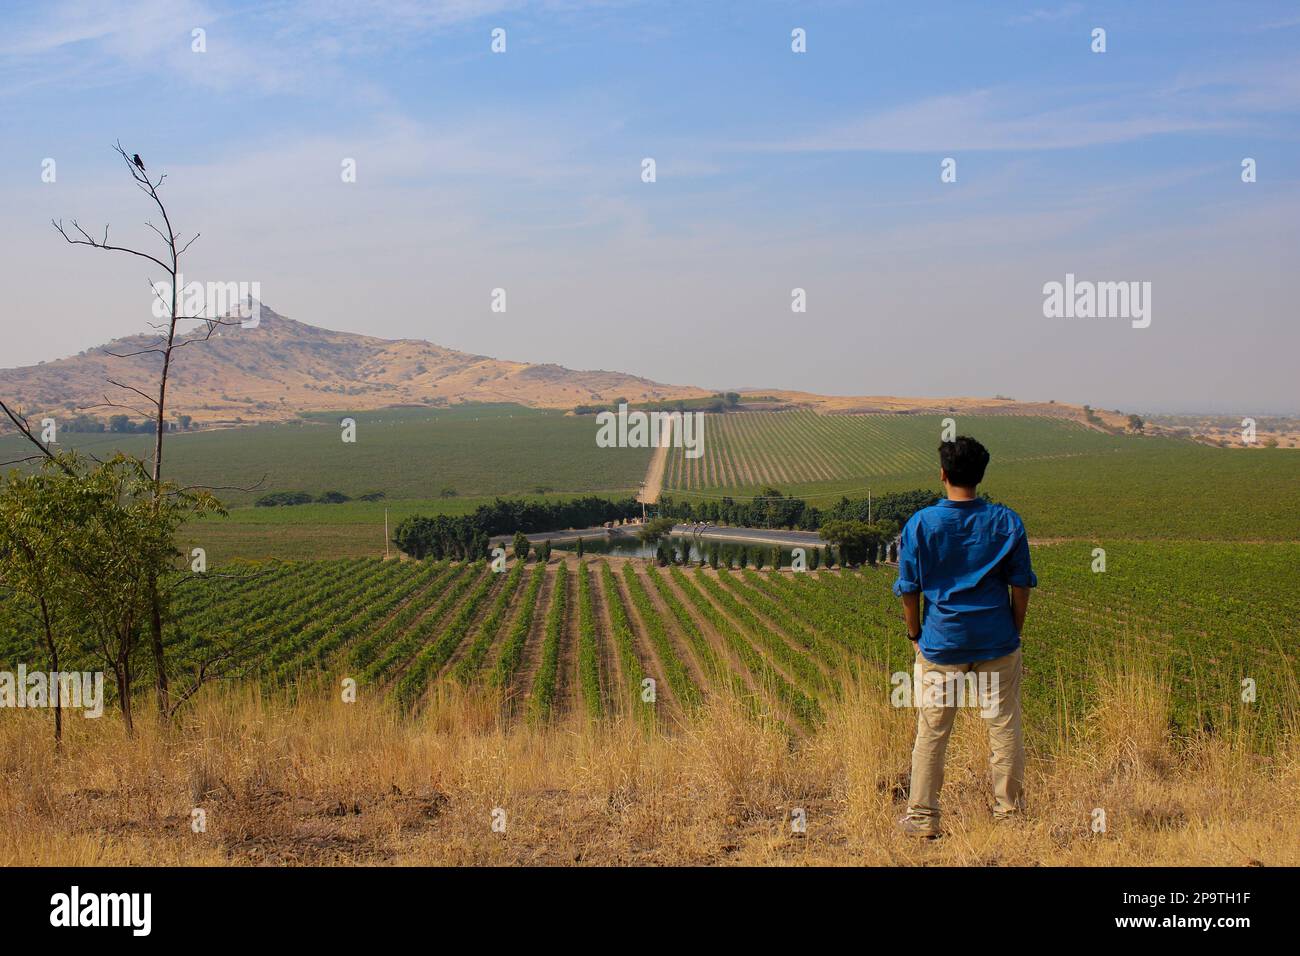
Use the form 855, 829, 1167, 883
0, 663, 1300, 866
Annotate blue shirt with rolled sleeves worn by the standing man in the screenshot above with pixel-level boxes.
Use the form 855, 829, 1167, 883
894, 498, 1039, 663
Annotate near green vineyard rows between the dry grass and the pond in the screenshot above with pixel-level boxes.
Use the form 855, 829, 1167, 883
0, 542, 1300, 747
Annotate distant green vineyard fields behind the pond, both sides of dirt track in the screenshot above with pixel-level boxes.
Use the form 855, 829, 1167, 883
0, 405, 1300, 562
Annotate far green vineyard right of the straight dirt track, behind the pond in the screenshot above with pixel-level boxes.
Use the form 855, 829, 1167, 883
664, 412, 1300, 541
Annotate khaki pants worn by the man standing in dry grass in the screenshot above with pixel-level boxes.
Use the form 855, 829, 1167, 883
907, 648, 1024, 832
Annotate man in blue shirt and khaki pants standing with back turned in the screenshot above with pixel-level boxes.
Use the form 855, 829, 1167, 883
894, 436, 1039, 838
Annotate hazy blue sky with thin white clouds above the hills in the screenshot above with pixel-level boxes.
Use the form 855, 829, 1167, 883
0, 0, 1300, 414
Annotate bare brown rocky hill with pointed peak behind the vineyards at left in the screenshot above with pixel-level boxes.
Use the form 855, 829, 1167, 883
0, 304, 710, 423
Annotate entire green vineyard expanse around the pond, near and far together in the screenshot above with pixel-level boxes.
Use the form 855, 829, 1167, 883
0, 406, 1300, 737
